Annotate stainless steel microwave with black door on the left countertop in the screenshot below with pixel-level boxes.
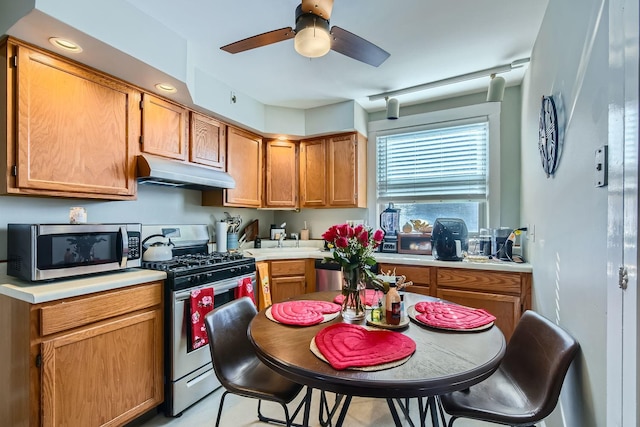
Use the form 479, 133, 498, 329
7, 224, 142, 282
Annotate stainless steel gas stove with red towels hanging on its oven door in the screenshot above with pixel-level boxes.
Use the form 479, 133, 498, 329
142, 225, 257, 416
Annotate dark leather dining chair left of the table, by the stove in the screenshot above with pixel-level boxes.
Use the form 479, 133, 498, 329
205, 297, 310, 427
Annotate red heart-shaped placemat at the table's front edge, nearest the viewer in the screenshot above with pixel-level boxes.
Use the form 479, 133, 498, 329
315, 323, 416, 370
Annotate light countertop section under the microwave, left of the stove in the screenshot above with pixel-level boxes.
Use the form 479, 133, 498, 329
0, 268, 167, 304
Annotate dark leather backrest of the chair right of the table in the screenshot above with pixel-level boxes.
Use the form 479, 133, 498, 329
500, 310, 580, 419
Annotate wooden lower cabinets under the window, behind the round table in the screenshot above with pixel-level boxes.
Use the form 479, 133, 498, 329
378, 263, 531, 341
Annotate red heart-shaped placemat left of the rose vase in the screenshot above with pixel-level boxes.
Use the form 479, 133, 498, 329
271, 300, 340, 326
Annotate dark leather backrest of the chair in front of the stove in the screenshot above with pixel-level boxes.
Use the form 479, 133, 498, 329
205, 297, 257, 386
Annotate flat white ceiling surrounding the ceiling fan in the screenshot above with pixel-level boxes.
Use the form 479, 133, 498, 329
121, 0, 548, 112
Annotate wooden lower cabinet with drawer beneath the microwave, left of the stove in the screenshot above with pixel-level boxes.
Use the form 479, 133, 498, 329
0, 282, 164, 427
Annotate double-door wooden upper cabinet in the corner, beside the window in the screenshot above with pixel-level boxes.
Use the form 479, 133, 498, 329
300, 132, 367, 208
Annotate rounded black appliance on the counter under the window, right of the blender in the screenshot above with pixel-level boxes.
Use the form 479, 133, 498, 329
431, 218, 469, 261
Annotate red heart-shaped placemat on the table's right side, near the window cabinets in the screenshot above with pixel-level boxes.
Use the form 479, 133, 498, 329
415, 301, 496, 329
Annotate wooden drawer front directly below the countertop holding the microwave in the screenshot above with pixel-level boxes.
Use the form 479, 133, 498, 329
38, 282, 162, 336
